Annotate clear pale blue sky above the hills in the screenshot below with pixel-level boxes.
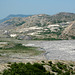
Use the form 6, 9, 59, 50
0, 0, 75, 19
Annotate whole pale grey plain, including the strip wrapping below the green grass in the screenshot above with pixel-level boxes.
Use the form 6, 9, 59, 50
0, 40, 75, 63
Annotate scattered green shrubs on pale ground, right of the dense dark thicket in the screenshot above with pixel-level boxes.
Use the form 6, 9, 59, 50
48, 61, 75, 75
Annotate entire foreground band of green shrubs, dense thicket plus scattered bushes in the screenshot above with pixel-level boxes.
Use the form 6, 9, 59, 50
2, 61, 75, 75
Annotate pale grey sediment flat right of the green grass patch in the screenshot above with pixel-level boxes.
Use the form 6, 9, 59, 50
28, 40, 75, 61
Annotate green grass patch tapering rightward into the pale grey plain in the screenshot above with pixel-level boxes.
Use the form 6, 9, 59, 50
0, 44, 43, 55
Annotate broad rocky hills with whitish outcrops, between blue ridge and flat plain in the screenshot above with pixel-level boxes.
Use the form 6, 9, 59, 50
0, 12, 75, 39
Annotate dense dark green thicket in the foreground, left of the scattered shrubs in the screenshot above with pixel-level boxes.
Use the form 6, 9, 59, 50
3, 63, 50, 75
